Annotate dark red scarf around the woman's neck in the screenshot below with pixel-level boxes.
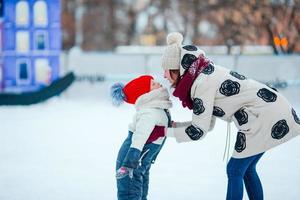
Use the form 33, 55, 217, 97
173, 54, 210, 110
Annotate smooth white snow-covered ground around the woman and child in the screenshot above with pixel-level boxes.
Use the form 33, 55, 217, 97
0, 83, 300, 200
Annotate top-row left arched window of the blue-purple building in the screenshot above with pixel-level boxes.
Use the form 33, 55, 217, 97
16, 1, 29, 26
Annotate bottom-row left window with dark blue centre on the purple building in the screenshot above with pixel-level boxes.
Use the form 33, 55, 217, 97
16, 59, 31, 85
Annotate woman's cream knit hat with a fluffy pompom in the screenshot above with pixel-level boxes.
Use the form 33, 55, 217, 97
162, 32, 183, 70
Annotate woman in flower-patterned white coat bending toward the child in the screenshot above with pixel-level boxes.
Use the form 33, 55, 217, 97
162, 33, 300, 200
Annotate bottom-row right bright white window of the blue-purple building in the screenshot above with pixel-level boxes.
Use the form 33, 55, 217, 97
34, 58, 51, 85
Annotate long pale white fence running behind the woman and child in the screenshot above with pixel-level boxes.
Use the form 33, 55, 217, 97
63, 52, 300, 81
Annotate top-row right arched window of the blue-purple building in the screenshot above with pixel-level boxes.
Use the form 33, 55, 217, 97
33, 0, 48, 26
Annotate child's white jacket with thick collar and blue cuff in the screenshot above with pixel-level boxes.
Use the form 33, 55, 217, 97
123, 88, 172, 168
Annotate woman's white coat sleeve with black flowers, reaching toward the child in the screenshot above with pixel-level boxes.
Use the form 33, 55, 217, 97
174, 76, 216, 142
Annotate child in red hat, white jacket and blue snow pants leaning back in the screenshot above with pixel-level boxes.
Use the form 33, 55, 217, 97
111, 75, 172, 200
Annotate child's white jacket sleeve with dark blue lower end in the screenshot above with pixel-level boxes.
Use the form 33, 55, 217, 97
123, 111, 156, 168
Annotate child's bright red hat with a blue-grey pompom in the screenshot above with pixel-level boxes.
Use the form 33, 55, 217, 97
111, 75, 153, 106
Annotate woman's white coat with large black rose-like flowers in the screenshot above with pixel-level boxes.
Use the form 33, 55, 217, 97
170, 46, 300, 158
